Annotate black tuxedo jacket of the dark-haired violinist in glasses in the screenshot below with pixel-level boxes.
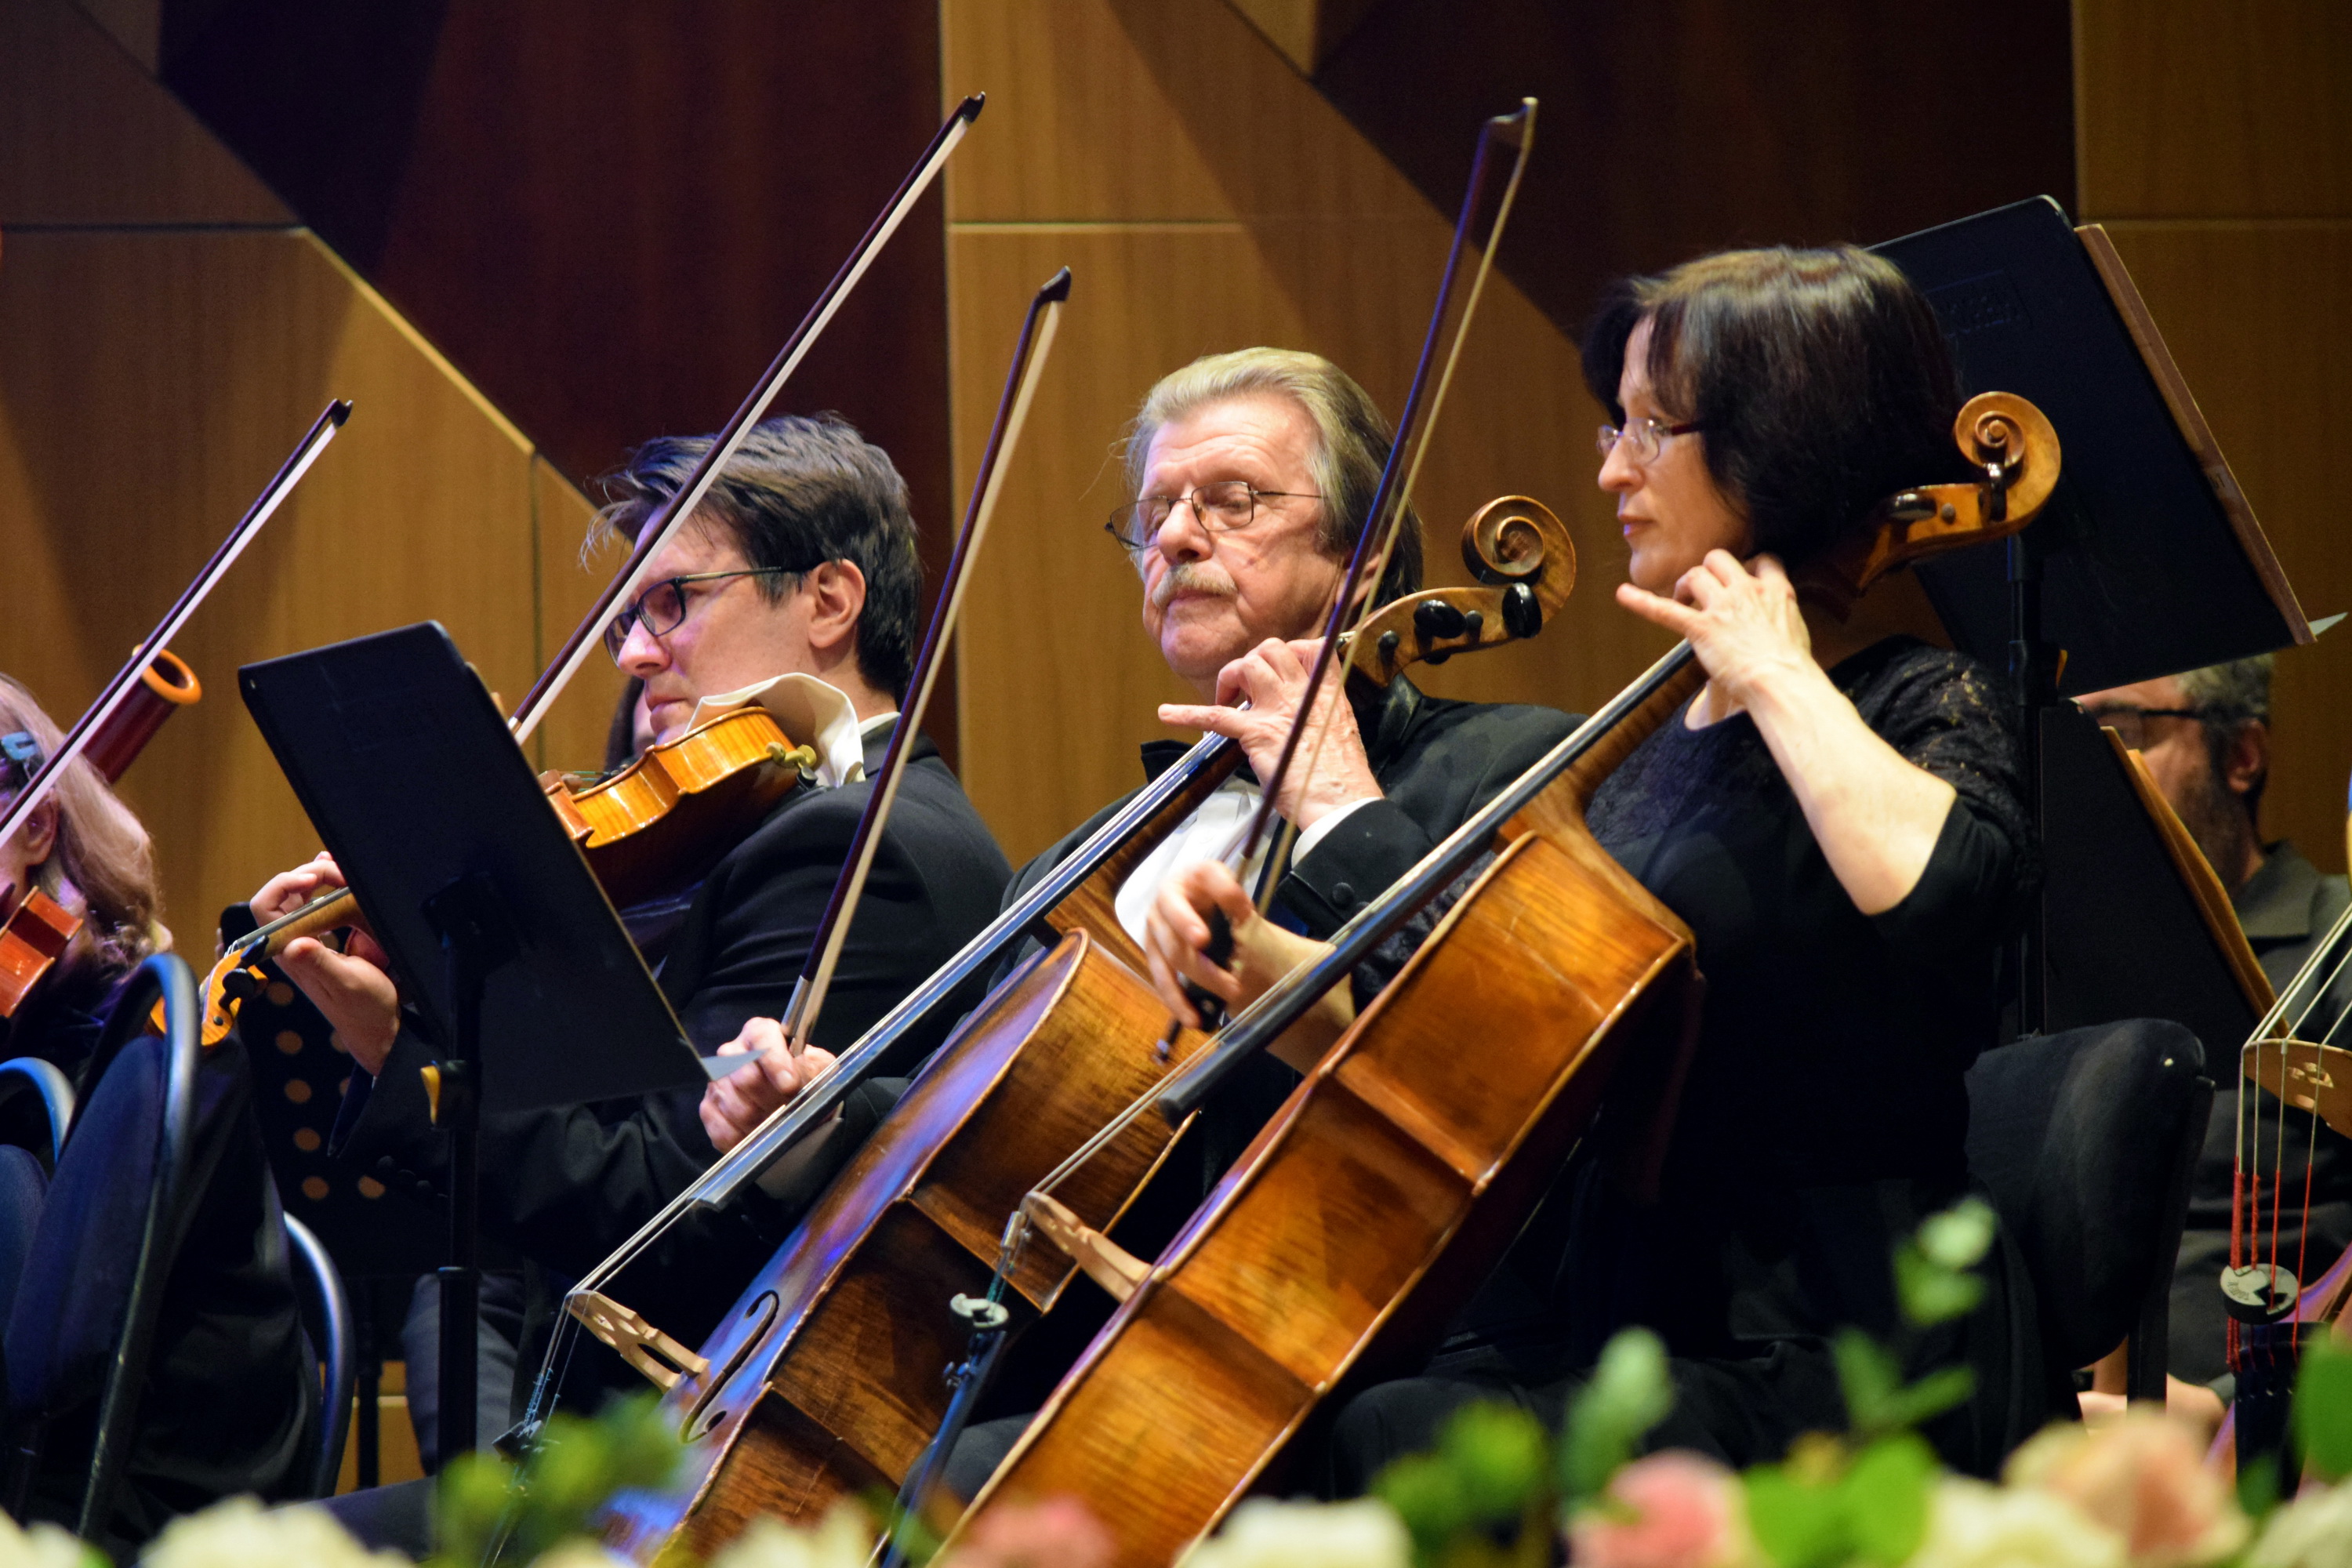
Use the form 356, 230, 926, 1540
329, 729, 1009, 1342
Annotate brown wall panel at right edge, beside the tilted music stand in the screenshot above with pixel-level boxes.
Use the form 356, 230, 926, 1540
2110, 223, 2352, 867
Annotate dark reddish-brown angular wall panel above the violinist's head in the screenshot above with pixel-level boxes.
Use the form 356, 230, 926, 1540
162, 0, 955, 755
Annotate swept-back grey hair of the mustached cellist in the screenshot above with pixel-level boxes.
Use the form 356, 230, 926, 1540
1127, 348, 1421, 604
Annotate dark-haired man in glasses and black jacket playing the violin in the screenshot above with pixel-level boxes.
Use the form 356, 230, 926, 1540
254, 416, 1009, 1495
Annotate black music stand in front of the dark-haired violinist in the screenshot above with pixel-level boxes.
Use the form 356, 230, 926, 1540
238, 621, 708, 1462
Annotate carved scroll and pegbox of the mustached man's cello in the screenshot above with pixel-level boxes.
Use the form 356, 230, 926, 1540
1343, 496, 1576, 687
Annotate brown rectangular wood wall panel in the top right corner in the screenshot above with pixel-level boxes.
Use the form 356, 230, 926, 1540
2074, 0, 2352, 219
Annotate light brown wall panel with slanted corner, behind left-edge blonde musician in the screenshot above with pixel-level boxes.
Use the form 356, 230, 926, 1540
0, 230, 609, 952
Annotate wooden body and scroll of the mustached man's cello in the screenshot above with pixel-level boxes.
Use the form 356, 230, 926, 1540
588, 496, 1576, 1561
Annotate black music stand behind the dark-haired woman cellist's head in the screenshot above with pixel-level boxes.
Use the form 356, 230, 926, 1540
1872, 198, 2312, 1046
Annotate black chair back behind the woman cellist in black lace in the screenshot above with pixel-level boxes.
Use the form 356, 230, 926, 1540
1969, 1018, 2213, 1399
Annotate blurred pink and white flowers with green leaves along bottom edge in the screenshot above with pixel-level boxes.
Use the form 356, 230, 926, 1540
41, 1201, 2352, 1568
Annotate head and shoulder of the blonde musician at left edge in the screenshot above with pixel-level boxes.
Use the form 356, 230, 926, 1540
0, 675, 172, 1076
